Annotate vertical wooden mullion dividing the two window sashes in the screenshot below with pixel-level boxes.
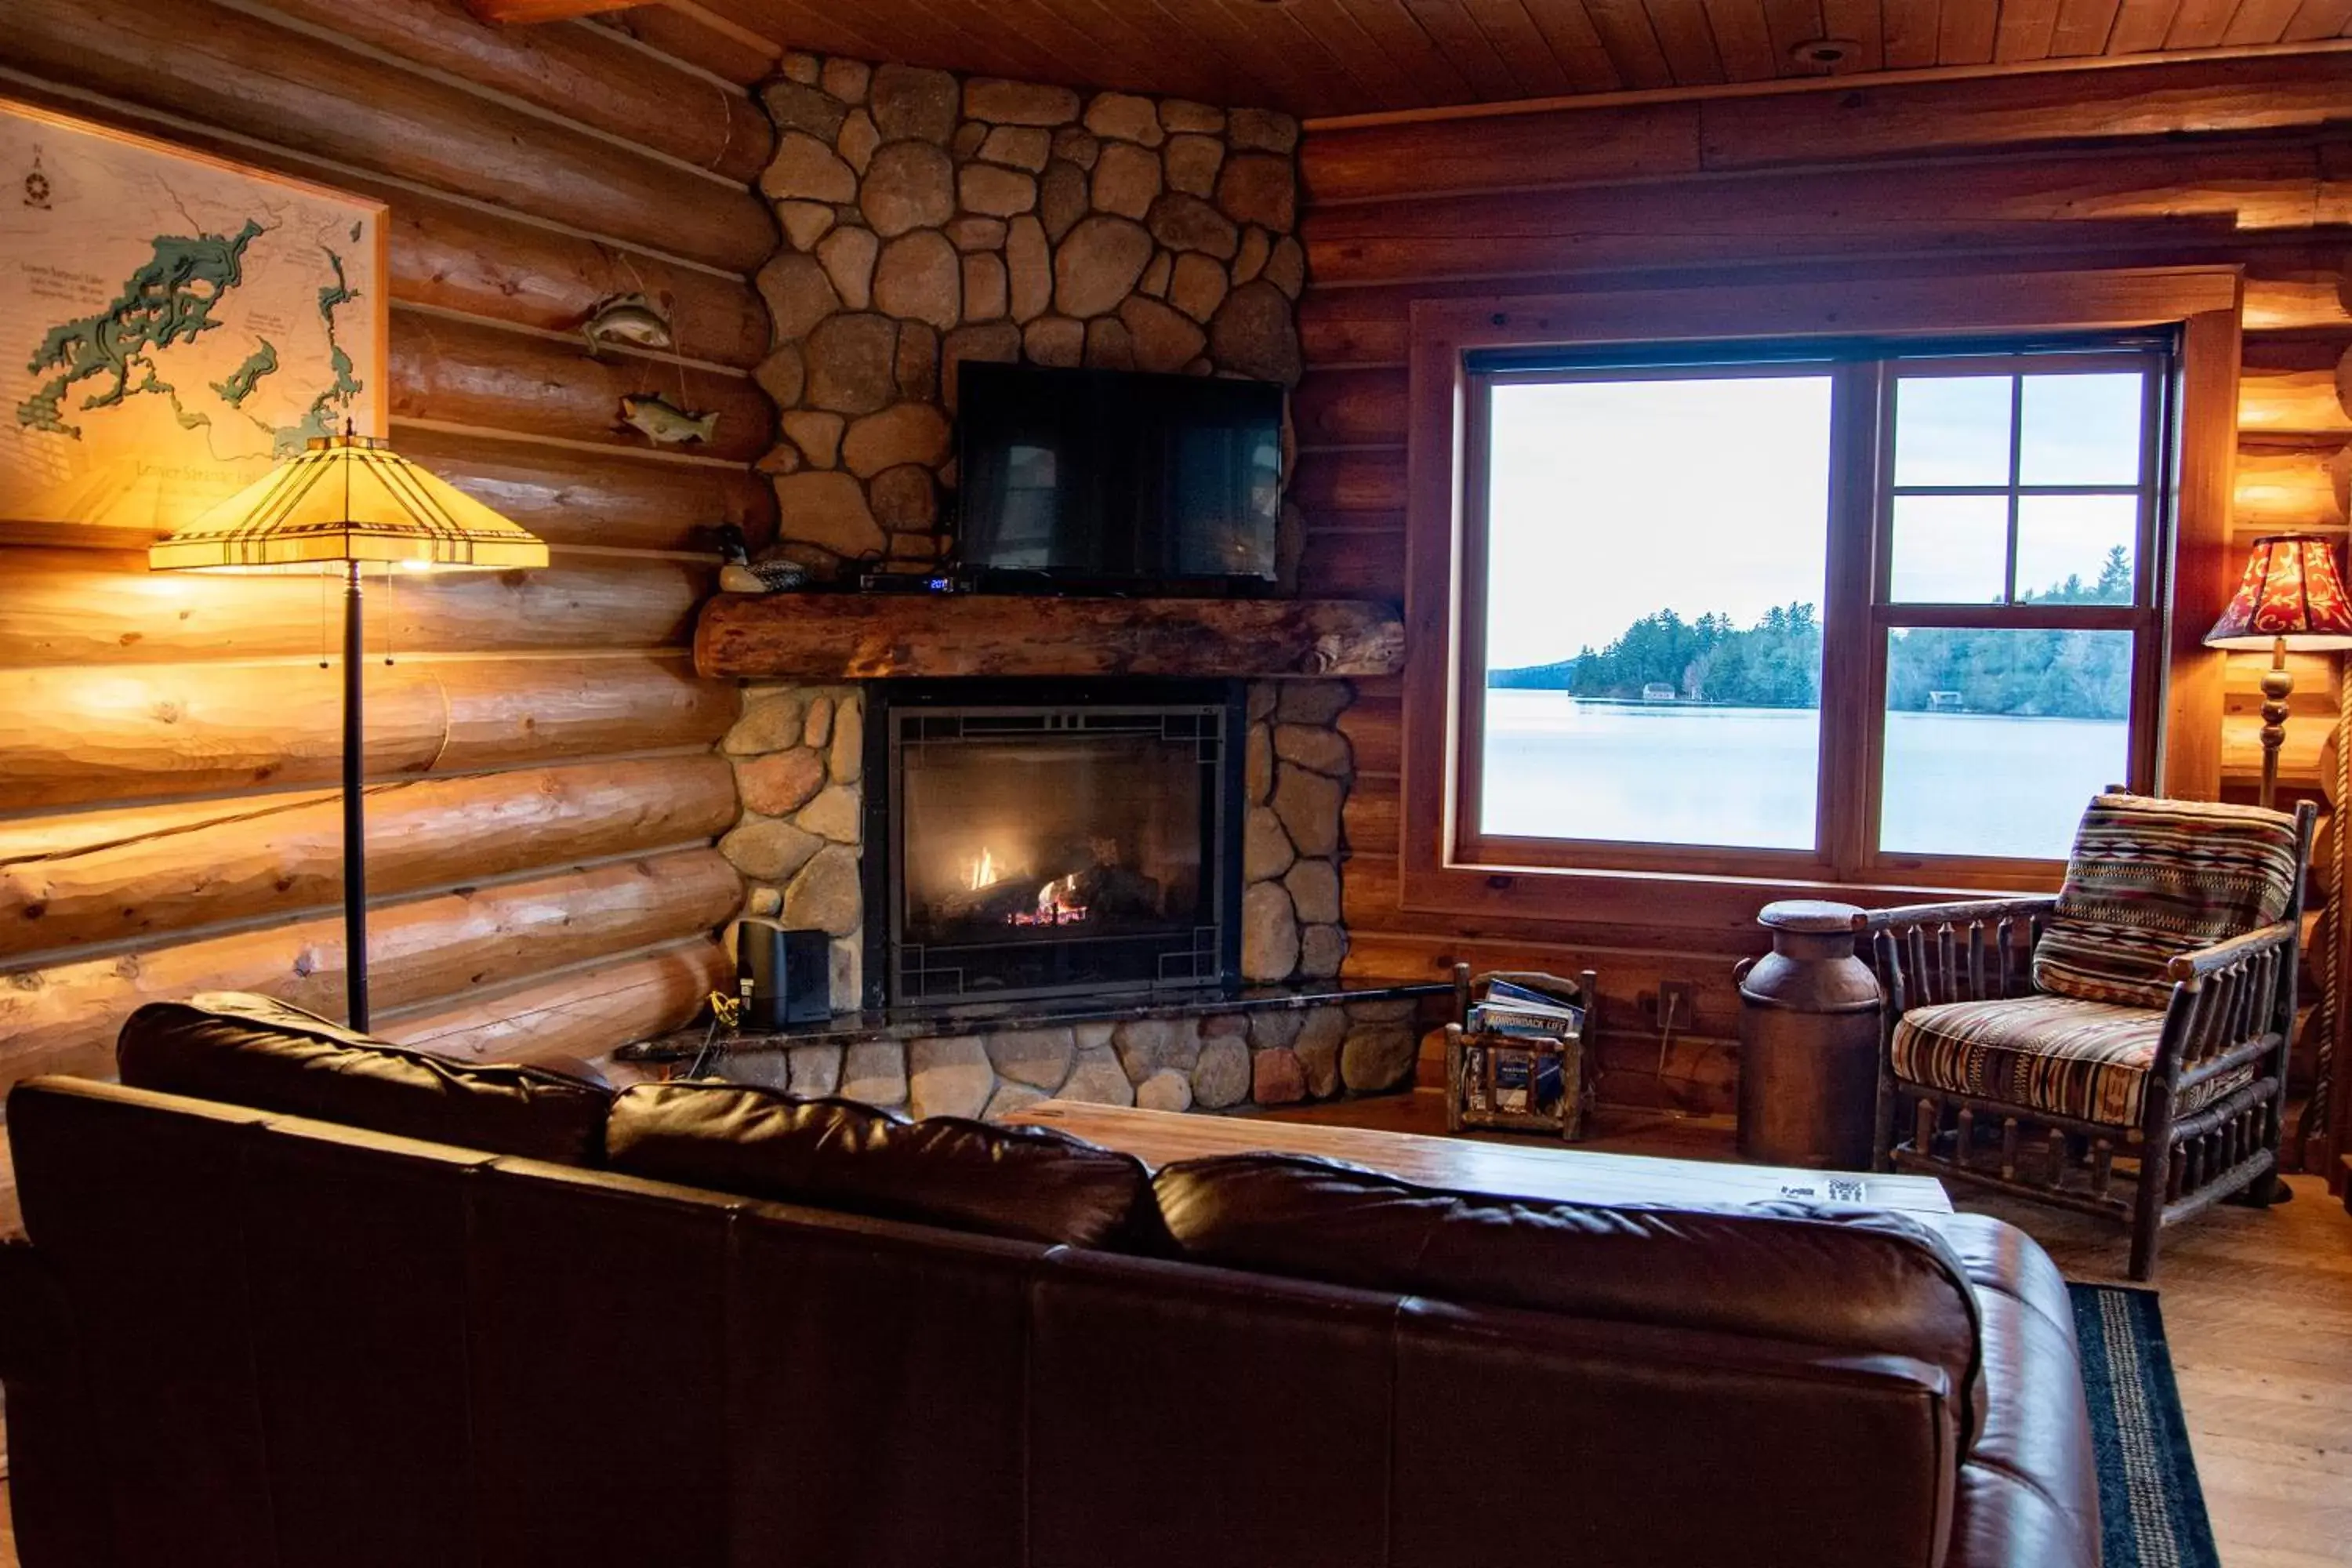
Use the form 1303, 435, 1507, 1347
1818, 362, 1889, 877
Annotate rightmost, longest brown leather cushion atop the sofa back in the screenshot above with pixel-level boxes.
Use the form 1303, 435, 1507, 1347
1155, 1154, 1983, 1450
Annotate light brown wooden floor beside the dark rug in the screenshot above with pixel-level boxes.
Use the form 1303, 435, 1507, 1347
1277, 1091, 2352, 1568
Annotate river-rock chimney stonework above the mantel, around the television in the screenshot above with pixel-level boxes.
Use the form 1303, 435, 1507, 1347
760, 54, 1305, 576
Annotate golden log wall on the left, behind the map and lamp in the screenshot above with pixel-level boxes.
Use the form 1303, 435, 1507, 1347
0, 0, 776, 1203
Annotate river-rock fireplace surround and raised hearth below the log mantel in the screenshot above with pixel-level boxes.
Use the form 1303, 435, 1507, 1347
687, 680, 1444, 1116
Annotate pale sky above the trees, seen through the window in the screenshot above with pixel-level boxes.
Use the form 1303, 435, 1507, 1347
1486, 374, 2140, 670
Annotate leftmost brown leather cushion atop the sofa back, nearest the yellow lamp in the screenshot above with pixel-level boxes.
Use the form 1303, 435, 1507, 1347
115, 992, 612, 1166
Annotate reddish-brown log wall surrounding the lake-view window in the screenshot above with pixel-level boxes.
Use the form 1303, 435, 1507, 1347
1296, 54, 2352, 1112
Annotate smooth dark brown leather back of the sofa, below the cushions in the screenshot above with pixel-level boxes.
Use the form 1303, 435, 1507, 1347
0, 1079, 1962, 1568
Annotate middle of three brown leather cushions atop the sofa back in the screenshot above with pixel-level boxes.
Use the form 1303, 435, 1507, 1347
607, 1081, 1150, 1246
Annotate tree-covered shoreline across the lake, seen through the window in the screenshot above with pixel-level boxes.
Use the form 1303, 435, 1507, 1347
1486, 546, 2131, 720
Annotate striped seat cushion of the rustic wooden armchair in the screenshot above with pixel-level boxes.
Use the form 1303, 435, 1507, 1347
1893, 996, 2253, 1126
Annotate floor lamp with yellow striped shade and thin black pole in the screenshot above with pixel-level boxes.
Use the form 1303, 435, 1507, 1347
148, 433, 548, 1029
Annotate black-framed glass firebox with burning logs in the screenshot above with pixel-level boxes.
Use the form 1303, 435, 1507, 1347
866, 680, 1244, 1006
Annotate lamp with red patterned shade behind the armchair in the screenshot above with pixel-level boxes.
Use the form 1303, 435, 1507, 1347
2206, 534, 2352, 1185
